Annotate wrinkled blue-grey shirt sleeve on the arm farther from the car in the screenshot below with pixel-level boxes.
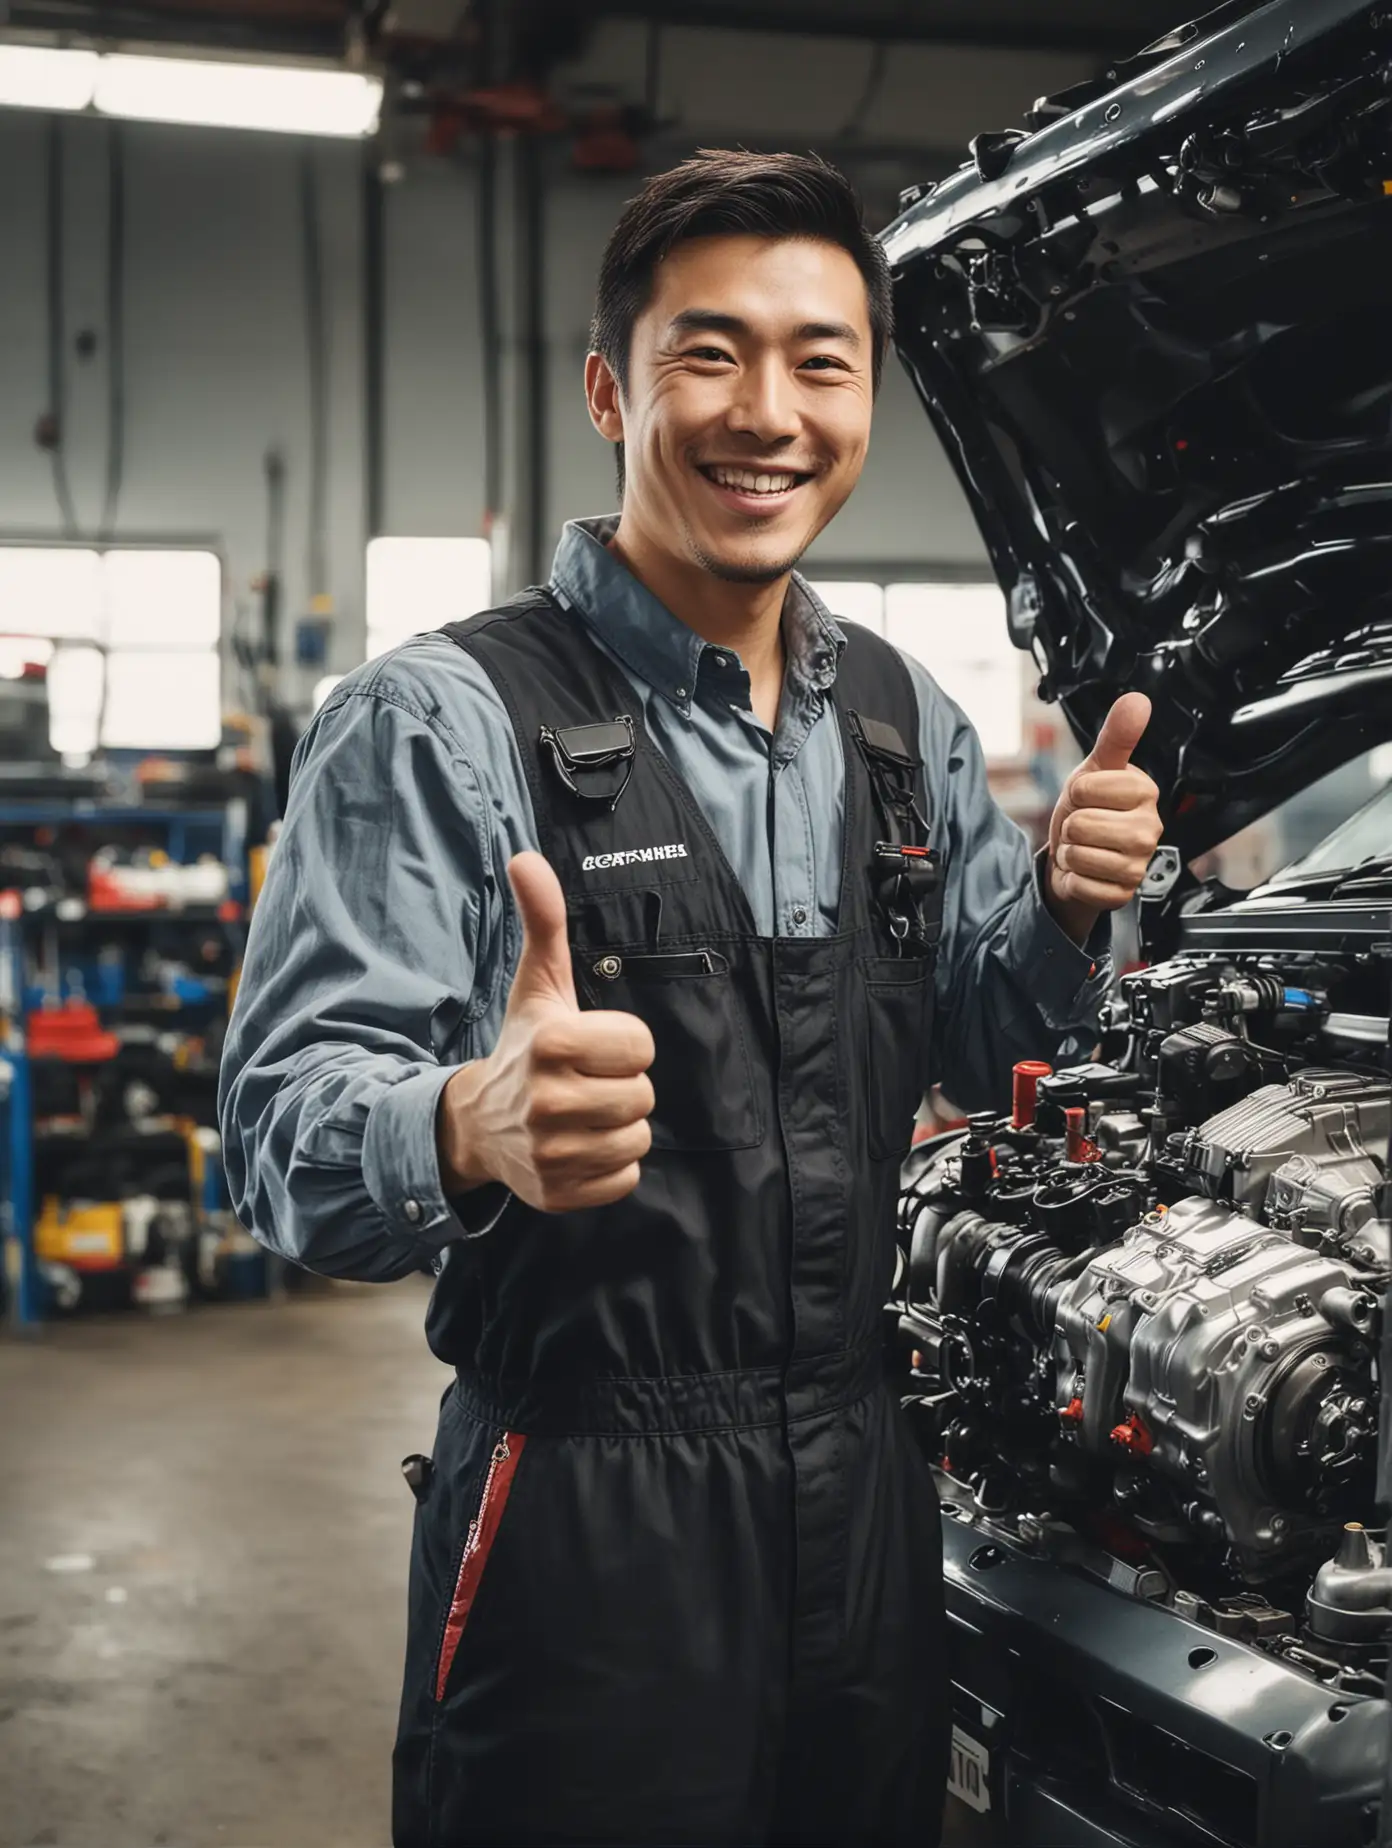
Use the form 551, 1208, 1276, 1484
220, 680, 507, 1283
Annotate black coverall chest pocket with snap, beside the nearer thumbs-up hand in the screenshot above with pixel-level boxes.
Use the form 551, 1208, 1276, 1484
575, 948, 763, 1151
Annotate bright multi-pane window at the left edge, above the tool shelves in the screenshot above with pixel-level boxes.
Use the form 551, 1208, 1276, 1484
0, 545, 222, 756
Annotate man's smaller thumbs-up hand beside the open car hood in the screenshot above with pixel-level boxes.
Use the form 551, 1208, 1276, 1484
1046, 693, 1163, 942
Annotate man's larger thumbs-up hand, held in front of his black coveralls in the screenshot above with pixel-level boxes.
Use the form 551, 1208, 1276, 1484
436, 854, 653, 1212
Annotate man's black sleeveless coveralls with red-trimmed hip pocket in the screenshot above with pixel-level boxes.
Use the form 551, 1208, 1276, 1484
394, 593, 948, 1848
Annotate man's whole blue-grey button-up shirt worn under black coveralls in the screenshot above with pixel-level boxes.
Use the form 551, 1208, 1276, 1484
220, 521, 1109, 1281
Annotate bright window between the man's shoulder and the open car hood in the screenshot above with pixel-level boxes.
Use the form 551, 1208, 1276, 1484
812, 580, 1024, 760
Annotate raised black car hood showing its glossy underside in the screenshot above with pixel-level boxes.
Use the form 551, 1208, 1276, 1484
884, 0, 1392, 859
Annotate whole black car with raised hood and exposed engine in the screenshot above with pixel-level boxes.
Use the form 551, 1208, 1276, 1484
884, 0, 1392, 1848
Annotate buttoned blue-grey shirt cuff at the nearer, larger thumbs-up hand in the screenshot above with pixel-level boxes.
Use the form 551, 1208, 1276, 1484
362, 1066, 512, 1249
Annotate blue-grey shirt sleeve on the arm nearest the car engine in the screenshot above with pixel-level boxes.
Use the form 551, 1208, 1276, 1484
906, 658, 1111, 1111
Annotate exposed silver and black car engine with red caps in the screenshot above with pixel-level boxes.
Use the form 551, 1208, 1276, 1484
897, 954, 1392, 1693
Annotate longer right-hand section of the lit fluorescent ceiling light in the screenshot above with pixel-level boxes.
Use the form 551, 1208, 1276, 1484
94, 52, 383, 139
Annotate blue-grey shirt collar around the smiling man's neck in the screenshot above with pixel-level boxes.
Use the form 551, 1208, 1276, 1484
551, 514, 847, 715
